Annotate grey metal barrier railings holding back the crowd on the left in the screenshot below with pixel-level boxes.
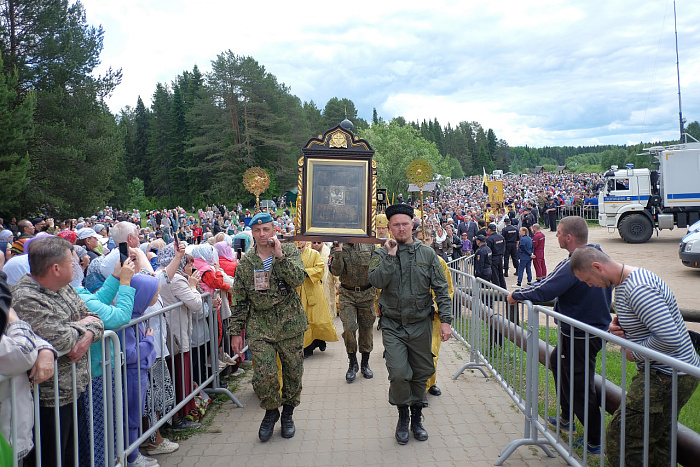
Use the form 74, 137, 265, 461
0, 293, 248, 467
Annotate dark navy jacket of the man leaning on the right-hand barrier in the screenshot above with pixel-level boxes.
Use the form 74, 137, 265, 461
513, 245, 612, 336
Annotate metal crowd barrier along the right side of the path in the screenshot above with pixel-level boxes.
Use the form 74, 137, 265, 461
450, 260, 700, 466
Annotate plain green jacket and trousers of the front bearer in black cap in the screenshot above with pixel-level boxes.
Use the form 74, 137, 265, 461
369, 240, 452, 406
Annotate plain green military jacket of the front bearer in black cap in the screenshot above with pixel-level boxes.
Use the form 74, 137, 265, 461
369, 240, 452, 326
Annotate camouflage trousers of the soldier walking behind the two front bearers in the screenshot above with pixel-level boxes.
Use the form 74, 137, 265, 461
339, 287, 377, 353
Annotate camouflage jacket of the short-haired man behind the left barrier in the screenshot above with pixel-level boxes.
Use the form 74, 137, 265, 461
12, 274, 104, 407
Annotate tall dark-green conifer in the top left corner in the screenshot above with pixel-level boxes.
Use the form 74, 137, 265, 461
0, 0, 123, 216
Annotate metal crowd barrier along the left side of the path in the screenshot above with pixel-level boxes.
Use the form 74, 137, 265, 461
0, 293, 247, 467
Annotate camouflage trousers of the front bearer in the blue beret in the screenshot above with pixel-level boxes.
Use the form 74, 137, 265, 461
248, 333, 304, 410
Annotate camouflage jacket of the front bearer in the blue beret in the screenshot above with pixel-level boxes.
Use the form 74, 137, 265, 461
228, 243, 309, 342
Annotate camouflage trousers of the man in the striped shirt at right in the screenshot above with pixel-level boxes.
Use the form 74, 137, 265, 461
605, 370, 698, 466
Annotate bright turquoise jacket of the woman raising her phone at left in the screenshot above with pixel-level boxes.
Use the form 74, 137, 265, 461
75, 274, 136, 378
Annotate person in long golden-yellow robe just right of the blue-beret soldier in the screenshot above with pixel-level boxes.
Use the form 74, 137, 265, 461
295, 242, 338, 357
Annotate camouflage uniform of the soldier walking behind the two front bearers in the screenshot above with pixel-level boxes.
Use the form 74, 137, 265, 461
330, 243, 376, 354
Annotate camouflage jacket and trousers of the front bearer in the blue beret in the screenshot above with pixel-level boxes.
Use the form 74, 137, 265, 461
228, 243, 308, 410
